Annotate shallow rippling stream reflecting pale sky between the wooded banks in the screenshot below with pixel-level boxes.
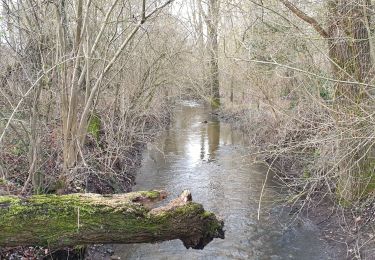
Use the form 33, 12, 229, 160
114, 101, 331, 260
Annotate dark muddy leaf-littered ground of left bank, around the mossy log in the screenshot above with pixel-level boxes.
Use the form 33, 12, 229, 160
0, 104, 173, 259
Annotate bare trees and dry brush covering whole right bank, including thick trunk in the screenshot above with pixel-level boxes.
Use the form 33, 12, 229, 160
213, 0, 375, 259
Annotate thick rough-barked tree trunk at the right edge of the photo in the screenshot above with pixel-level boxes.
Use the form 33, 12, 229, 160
328, 0, 373, 202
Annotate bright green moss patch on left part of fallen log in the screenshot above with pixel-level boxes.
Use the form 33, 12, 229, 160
0, 195, 155, 245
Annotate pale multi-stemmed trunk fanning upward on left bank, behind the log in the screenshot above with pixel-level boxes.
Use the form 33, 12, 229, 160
58, 0, 173, 189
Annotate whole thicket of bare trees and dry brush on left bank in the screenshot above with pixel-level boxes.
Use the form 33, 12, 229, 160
0, 1, 184, 193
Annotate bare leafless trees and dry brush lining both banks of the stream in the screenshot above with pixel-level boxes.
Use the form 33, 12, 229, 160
0, 0, 375, 254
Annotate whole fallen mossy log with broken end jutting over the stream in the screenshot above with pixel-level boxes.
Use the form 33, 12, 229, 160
0, 191, 224, 249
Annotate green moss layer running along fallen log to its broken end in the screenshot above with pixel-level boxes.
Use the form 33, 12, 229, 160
0, 191, 220, 247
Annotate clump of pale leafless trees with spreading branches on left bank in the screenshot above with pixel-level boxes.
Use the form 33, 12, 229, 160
0, 0, 180, 192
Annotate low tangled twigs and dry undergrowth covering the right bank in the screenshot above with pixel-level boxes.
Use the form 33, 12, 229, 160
219, 98, 375, 259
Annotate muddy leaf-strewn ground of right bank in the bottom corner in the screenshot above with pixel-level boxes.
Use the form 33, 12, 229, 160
295, 198, 375, 259
